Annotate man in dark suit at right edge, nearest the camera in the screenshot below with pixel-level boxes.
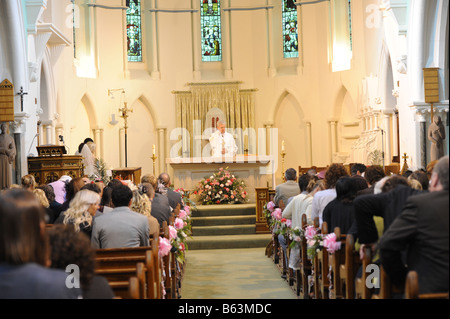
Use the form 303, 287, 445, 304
379, 156, 449, 293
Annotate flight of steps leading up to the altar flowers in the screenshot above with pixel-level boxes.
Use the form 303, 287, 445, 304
188, 204, 271, 250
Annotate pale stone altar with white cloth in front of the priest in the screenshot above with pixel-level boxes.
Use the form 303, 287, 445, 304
166, 155, 276, 203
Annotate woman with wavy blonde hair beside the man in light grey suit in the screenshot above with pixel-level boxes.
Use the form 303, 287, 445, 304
55, 189, 100, 238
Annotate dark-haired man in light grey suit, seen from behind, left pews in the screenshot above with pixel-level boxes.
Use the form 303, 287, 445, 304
91, 185, 150, 249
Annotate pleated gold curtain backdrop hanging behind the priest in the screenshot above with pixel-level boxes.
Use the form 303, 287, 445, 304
173, 82, 257, 157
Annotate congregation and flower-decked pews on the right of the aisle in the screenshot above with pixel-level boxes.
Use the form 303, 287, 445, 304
264, 156, 449, 299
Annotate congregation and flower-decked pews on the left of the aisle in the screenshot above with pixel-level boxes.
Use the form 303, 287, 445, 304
0, 173, 191, 299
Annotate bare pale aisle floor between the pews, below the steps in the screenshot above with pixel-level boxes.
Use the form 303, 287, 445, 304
181, 248, 297, 299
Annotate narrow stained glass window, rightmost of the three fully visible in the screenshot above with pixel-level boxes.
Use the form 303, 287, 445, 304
282, 0, 298, 58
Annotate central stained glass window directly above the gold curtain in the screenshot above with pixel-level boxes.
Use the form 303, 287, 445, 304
200, 0, 222, 62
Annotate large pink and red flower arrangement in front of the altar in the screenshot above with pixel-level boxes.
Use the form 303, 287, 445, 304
194, 167, 248, 205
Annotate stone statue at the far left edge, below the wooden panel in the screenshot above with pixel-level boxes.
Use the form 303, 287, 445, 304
0, 123, 16, 190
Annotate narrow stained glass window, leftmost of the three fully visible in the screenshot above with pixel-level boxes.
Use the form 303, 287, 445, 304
127, 0, 142, 62
